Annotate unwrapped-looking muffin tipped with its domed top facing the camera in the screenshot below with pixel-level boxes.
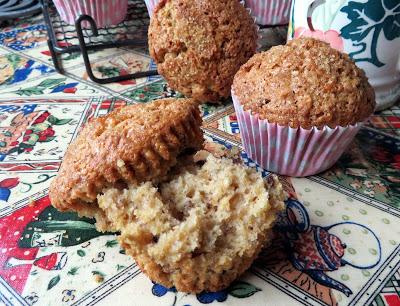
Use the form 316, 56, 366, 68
149, 0, 257, 102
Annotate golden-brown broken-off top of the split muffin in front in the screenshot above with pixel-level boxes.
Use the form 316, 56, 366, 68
49, 99, 203, 231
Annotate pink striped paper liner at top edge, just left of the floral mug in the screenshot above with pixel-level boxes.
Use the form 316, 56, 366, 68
245, 0, 292, 25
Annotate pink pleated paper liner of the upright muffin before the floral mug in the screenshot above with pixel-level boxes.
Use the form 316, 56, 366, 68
232, 92, 362, 177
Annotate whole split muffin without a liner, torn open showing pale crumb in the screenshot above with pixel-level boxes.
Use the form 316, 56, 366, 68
50, 99, 284, 293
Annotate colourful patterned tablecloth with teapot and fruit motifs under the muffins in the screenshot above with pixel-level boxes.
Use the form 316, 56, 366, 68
0, 4, 400, 306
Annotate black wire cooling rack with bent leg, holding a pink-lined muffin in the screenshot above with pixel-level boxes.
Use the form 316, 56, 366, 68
40, 0, 158, 84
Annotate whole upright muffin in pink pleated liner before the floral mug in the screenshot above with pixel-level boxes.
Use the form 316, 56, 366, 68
232, 38, 375, 176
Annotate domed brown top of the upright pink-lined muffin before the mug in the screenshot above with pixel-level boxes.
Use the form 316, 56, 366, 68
232, 38, 375, 129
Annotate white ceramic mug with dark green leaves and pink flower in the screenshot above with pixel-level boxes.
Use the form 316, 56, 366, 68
288, 0, 400, 110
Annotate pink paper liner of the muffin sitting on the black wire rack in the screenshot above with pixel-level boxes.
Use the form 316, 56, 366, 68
53, 0, 128, 27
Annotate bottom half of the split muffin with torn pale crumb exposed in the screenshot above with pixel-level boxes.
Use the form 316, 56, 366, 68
98, 155, 284, 293
